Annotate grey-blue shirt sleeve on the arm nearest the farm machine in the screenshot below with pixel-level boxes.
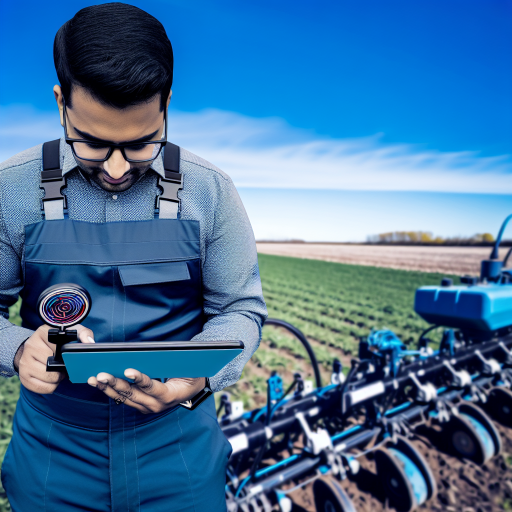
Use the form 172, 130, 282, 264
192, 174, 268, 391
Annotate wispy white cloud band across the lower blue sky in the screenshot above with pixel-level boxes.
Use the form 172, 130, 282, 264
0, 106, 512, 194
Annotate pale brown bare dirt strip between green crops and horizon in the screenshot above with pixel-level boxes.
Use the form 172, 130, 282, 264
256, 242, 508, 275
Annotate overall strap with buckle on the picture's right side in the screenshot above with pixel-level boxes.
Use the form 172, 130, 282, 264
155, 142, 183, 219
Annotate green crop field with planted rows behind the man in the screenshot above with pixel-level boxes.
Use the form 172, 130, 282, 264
0, 255, 454, 512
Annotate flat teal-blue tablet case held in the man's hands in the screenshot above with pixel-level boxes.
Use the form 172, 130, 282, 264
62, 348, 242, 384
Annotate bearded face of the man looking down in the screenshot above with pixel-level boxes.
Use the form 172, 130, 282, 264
56, 87, 164, 193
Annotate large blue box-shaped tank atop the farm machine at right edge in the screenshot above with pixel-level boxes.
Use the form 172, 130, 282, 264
414, 283, 512, 332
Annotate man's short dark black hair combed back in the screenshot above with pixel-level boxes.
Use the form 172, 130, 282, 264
53, 2, 173, 110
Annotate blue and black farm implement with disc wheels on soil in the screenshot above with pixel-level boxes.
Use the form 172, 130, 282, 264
222, 215, 512, 512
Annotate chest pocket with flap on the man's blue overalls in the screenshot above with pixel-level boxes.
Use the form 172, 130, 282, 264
118, 259, 203, 341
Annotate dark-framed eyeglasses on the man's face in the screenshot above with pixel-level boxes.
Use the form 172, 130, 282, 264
62, 98, 167, 163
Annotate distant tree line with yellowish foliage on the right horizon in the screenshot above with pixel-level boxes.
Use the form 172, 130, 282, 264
366, 231, 511, 245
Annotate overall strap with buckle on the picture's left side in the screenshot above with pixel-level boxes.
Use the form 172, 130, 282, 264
39, 139, 67, 220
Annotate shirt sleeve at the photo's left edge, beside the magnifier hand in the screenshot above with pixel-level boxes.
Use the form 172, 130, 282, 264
0, 202, 34, 377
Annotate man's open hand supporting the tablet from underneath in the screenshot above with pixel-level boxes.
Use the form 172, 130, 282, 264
87, 368, 206, 414
